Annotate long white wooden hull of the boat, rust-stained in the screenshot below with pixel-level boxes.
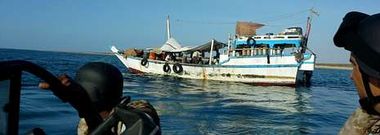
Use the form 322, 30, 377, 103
110, 47, 299, 85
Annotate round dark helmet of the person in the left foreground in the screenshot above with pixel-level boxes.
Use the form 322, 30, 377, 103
75, 62, 123, 112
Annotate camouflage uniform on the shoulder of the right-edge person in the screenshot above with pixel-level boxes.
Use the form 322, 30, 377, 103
339, 108, 380, 135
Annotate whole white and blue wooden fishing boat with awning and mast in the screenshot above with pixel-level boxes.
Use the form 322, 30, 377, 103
111, 15, 316, 85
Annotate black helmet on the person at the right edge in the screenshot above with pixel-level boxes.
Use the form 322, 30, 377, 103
334, 12, 380, 79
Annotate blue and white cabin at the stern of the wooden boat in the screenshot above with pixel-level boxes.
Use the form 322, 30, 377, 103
226, 27, 304, 57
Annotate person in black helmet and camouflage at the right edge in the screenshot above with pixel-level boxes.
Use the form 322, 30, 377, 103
334, 12, 380, 135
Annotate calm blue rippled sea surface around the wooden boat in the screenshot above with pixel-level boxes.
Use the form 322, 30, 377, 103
0, 49, 358, 135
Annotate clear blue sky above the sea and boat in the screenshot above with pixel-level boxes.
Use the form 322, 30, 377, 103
0, 0, 380, 63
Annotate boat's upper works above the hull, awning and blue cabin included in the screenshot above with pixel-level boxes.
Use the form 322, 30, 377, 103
124, 27, 305, 65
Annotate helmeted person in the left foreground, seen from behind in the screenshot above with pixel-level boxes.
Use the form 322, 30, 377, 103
39, 62, 161, 135
